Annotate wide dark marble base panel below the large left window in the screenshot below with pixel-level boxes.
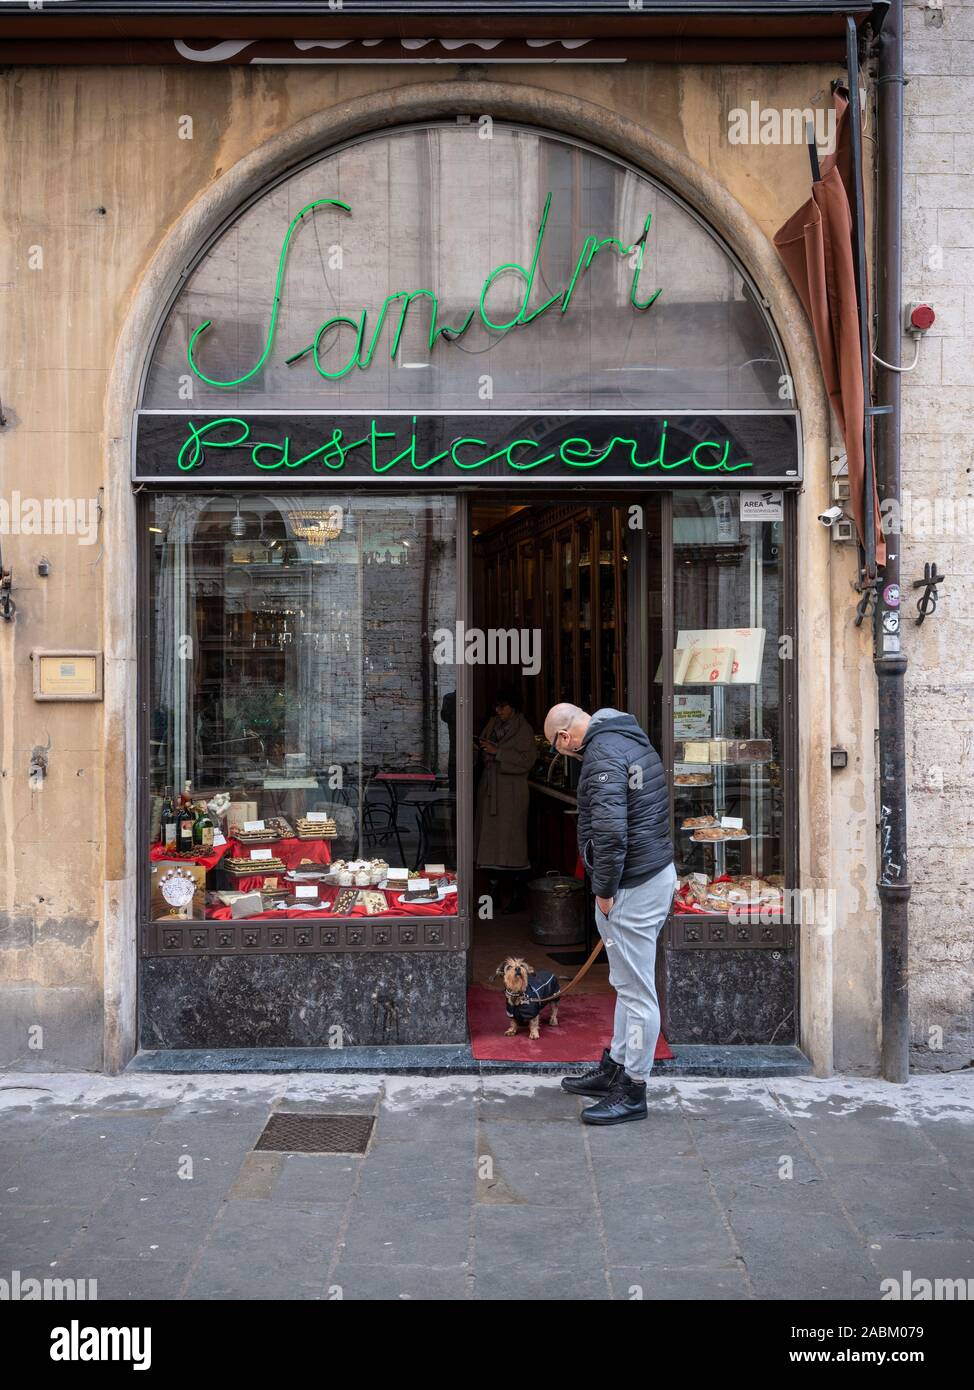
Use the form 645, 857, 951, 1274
139, 951, 467, 1048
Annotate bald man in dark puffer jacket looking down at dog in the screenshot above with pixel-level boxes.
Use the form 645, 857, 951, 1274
545, 705, 677, 1125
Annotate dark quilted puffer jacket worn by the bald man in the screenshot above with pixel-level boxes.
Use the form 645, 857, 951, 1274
578, 709, 672, 898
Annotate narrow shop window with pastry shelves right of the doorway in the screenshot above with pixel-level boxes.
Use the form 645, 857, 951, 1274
672, 491, 792, 920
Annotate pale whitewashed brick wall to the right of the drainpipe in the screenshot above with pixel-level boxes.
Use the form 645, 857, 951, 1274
902, 0, 974, 1070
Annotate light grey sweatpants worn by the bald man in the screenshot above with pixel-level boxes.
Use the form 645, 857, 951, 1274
595, 863, 677, 1081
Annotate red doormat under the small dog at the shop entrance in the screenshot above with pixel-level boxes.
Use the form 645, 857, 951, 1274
467, 984, 672, 1062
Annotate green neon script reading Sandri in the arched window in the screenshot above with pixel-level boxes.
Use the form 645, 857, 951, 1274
186, 193, 661, 388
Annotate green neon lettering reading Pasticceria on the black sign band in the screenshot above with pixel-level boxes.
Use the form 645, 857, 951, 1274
176, 416, 754, 474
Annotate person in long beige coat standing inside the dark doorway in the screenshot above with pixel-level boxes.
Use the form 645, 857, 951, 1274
474, 691, 538, 912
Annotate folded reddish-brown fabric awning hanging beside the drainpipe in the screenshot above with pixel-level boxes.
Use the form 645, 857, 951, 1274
774, 90, 886, 564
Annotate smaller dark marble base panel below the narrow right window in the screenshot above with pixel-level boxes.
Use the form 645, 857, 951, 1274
666, 948, 798, 1045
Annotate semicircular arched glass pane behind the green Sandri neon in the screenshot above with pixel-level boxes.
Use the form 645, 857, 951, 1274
142, 121, 793, 413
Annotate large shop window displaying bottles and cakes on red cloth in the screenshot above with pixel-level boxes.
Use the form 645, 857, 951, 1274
145, 492, 457, 920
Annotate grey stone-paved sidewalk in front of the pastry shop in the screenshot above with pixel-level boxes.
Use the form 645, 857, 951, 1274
0, 1072, 974, 1300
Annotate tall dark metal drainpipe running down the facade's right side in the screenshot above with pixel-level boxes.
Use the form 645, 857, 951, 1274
873, 0, 910, 1081
